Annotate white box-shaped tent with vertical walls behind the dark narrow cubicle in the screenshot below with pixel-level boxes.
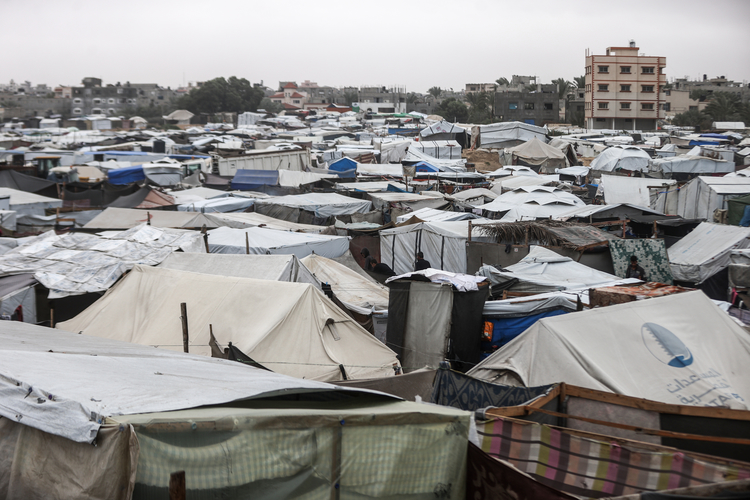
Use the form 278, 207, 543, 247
380, 221, 493, 274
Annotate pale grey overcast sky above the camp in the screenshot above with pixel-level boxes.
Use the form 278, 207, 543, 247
0, 0, 750, 92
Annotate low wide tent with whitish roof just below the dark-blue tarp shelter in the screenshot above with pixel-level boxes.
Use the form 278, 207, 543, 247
255, 193, 372, 222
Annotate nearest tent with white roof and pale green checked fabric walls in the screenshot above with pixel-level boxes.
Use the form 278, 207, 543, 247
0, 322, 470, 500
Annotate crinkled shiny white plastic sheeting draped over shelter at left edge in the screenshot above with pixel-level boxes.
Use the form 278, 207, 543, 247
0, 224, 203, 299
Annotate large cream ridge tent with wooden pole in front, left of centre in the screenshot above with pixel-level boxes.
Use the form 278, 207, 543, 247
58, 266, 399, 381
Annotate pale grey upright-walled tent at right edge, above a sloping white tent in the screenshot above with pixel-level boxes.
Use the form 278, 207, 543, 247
677, 176, 750, 220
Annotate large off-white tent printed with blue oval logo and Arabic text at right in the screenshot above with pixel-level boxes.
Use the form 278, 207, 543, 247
468, 291, 750, 409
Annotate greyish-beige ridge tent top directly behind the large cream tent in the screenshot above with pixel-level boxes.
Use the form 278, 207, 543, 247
159, 252, 320, 288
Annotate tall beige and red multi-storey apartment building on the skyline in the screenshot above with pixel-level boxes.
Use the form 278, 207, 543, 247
585, 42, 667, 130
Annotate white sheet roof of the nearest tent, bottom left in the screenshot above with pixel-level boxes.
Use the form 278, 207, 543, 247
0, 321, 385, 443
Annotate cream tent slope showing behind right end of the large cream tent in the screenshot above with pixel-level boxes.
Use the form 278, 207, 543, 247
301, 254, 388, 315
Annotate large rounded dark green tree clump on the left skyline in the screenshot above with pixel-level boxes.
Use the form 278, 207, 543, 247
179, 76, 263, 114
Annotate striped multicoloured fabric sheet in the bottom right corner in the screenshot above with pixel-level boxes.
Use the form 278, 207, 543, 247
477, 419, 750, 498
